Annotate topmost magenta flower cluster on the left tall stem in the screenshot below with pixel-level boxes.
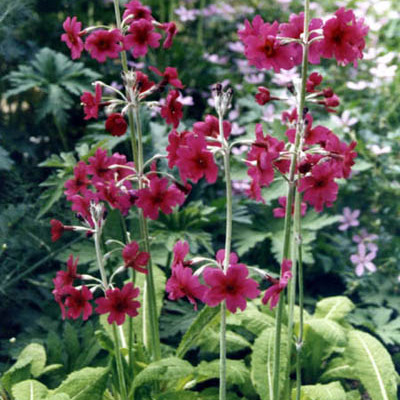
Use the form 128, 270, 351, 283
61, 0, 177, 63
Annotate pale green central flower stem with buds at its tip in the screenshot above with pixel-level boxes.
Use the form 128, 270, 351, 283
218, 112, 232, 400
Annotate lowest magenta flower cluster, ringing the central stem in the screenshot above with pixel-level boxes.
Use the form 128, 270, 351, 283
166, 242, 292, 313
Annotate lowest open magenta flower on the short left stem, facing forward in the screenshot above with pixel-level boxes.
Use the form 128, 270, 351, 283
95, 282, 140, 325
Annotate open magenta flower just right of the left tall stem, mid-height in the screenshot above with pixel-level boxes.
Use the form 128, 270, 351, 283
135, 176, 185, 220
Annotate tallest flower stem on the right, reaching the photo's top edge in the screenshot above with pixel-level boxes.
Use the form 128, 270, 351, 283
273, 0, 310, 400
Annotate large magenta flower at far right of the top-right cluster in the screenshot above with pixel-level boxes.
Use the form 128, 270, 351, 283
321, 7, 368, 66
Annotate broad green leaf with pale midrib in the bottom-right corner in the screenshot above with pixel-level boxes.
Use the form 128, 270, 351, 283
344, 330, 397, 400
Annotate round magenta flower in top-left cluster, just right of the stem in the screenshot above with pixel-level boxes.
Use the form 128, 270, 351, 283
124, 18, 162, 58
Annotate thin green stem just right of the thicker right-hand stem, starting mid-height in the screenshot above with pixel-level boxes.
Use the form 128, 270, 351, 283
294, 192, 304, 400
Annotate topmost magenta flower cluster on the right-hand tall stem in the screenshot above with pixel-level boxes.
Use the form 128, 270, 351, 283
238, 7, 368, 72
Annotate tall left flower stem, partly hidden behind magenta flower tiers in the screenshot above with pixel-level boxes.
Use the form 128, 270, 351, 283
114, 0, 163, 360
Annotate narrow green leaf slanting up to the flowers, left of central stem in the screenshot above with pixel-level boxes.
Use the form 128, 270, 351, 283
176, 306, 219, 358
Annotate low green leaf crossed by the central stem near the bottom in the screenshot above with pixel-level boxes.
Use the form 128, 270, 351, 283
195, 359, 250, 386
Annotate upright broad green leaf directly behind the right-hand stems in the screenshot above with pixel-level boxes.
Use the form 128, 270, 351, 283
251, 328, 288, 400
